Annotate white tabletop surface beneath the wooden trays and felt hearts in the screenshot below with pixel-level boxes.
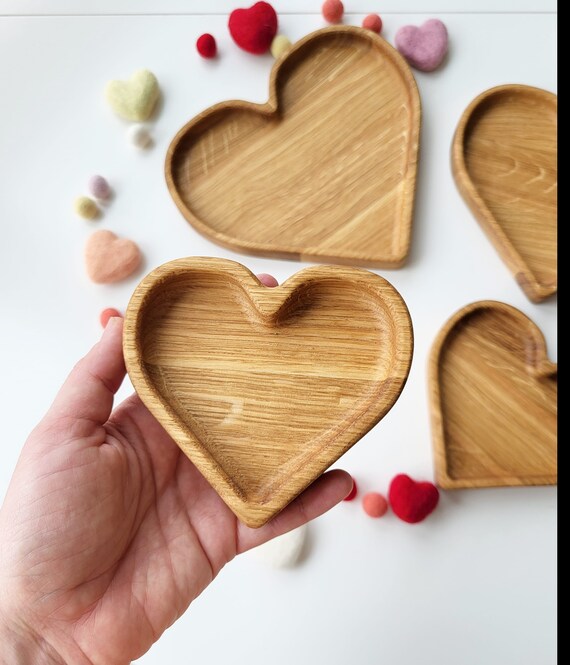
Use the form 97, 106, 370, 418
0, 0, 556, 665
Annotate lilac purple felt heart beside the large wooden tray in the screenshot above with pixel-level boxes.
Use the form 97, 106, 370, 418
396, 18, 448, 72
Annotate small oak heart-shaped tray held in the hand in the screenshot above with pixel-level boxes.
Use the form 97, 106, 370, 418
124, 258, 413, 527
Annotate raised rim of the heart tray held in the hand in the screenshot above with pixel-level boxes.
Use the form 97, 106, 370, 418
123, 257, 414, 527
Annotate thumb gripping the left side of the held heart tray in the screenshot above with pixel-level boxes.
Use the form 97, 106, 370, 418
48, 317, 125, 425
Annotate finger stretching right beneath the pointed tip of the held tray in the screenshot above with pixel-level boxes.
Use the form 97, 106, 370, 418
236, 469, 353, 554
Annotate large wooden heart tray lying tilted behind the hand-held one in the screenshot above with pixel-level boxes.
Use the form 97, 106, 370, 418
165, 26, 421, 268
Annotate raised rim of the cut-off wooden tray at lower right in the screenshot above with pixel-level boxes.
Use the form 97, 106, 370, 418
427, 300, 558, 490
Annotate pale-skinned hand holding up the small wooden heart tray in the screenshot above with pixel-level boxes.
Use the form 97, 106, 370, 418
0, 275, 352, 665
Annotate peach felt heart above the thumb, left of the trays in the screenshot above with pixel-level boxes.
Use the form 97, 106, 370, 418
85, 230, 141, 284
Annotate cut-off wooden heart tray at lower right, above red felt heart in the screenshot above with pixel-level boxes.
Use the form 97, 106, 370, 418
429, 301, 558, 489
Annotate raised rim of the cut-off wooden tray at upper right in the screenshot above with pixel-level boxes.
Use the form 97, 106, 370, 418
451, 83, 558, 302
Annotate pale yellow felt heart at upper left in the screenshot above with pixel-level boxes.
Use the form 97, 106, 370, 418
105, 69, 159, 122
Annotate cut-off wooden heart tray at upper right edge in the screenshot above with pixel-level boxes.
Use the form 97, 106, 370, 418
452, 85, 558, 302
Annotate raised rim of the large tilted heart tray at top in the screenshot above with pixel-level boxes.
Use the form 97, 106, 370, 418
164, 25, 422, 269
